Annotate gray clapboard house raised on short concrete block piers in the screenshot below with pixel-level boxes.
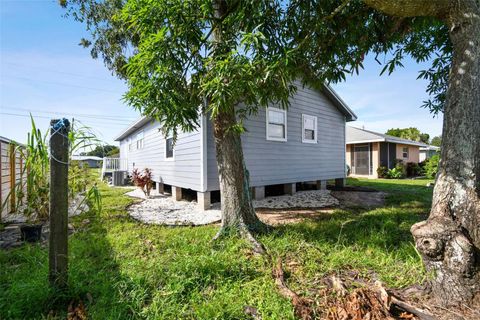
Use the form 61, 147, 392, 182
116, 82, 356, 209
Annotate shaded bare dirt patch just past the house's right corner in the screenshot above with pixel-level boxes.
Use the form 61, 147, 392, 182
331, 191, 387, 208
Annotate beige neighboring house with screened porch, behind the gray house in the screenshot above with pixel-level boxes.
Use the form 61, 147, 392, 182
346, 126, 427, 178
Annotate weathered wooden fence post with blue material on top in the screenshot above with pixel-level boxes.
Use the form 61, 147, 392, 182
49, 118, 70, 289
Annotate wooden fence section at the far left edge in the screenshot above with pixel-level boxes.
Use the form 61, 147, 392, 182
0, 137, 26, 221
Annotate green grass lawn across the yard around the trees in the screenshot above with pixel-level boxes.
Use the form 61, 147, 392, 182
0, 179, 431, 319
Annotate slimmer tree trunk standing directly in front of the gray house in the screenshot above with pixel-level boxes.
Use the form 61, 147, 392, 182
213, 0, 265, 253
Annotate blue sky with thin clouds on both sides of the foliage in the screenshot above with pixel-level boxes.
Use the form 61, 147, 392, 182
0, 0, 442, 143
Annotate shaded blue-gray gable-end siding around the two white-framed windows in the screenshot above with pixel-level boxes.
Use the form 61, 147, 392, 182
207, 83, 345, 190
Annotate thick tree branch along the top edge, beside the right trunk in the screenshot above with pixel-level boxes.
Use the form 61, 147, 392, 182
363, 0, 451, 18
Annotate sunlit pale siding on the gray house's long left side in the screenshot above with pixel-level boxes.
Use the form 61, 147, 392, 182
120, 121, 202, 190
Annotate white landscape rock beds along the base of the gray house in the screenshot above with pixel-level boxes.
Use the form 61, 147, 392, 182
126, 189, 338, 225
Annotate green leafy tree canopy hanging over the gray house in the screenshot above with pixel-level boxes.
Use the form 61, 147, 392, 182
61, 0, 451, 132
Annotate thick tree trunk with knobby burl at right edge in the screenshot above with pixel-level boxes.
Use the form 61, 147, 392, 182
411, 0, 480, 306
